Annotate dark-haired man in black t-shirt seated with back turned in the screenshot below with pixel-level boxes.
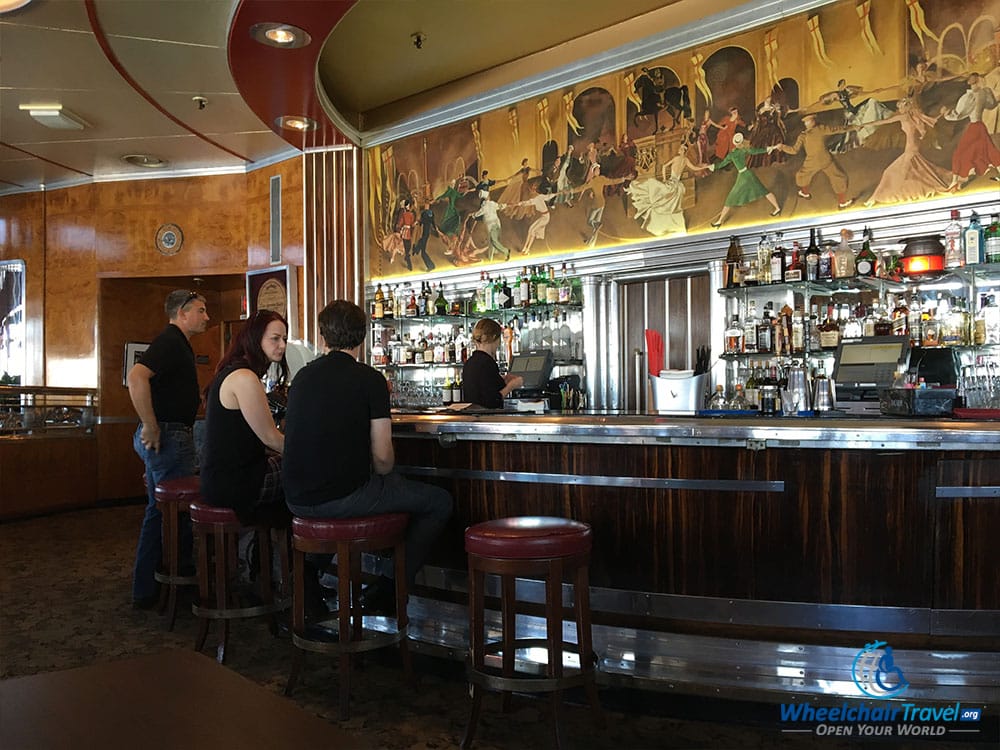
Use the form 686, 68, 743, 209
282, 300, 452, 611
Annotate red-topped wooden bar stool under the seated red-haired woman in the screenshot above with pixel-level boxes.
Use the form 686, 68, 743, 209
191, 502, 291, 664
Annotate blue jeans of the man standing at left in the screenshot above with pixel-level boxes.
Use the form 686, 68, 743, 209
132, 422, 198, 600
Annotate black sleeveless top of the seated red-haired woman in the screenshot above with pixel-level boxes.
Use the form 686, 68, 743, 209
201, 366, 267, 522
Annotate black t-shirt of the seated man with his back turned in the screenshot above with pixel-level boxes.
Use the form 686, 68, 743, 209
282, 351, 391, 505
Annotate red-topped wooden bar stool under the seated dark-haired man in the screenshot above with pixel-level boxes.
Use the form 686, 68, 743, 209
285, 513, 413, 720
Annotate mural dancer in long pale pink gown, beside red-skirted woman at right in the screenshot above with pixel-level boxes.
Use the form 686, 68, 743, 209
865, 99, 951, 206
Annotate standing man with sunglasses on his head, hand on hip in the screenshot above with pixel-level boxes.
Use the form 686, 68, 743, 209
126, 289, 208, 609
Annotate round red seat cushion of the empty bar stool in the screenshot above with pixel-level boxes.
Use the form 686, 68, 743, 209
465, 516, 593, 560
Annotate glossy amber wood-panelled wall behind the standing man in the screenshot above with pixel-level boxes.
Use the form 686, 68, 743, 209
0, 152, 328, 499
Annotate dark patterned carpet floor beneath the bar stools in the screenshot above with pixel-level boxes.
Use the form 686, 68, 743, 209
0, 505, 992, 750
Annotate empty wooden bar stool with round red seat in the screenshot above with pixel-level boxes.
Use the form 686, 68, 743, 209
462, 516, 604, 748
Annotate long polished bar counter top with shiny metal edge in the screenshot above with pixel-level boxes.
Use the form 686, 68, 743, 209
393, 409, 1000, 451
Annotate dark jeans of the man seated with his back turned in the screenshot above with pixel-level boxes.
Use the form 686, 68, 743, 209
288, 473, 452, 586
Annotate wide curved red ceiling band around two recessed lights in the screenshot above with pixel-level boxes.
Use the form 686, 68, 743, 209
228, 0, 357, 150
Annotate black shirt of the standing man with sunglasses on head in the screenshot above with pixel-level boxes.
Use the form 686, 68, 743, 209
139, 323, 201, 427
